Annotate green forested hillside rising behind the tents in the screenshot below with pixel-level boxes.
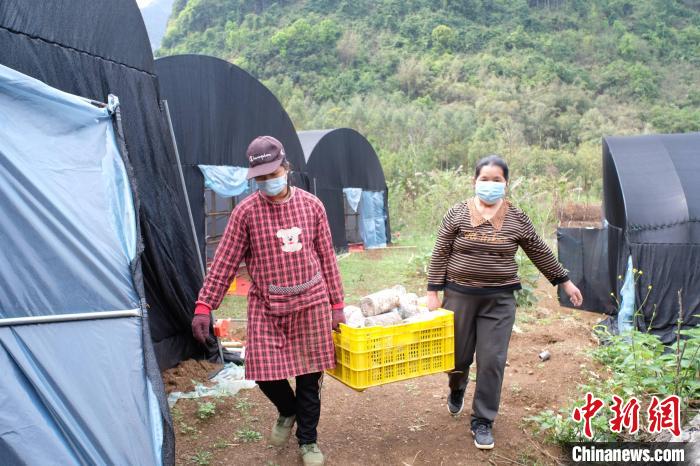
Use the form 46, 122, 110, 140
159, 0, 700, 221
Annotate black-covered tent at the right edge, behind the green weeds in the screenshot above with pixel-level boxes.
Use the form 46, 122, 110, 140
560, 133, 700, 343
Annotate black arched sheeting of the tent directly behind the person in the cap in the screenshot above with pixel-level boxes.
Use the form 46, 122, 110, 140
155, 55, 308, 258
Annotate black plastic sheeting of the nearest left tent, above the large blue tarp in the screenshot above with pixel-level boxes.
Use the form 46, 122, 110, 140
0, 0, 215, 369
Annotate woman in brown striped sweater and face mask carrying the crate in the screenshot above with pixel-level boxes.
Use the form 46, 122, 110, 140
428, 155, 583, 449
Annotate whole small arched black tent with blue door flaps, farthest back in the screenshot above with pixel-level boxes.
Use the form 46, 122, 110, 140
299, 128, 391, 249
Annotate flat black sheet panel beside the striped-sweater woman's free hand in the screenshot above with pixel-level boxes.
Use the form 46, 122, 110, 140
557, 228, 617, 314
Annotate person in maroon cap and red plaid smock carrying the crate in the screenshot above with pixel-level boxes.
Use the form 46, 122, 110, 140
192, 136, 344, 466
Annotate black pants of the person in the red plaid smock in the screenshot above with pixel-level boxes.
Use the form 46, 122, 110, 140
257, 372, 323, 445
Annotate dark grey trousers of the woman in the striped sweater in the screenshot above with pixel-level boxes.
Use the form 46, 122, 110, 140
443, 289, 515, 424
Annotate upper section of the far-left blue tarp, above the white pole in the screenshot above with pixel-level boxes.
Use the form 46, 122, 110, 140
0, 62, 139, 317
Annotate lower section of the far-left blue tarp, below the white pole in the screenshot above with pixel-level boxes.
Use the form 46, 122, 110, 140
0, 317, 162, 465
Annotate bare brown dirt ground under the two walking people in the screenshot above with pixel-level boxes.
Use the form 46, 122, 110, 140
168, 283, 600, 466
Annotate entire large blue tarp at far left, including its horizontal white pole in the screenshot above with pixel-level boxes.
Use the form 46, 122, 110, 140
0, 65, 167, 465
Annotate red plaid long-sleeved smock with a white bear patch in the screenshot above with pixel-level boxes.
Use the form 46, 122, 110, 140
198, 188, 343, 381
